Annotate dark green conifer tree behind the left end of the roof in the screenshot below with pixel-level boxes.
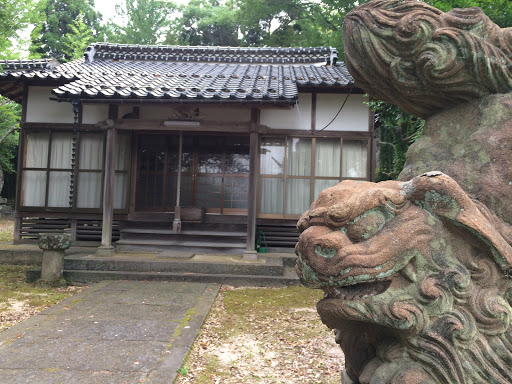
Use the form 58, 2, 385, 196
29, 0, 101, 61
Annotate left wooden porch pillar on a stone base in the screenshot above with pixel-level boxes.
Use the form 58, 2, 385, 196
96, 109, 117, 256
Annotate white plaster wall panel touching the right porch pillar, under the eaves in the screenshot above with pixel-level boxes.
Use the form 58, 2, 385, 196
260, 93, 312, 131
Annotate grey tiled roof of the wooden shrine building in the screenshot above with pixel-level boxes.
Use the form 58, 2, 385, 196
0, 43, 353, 103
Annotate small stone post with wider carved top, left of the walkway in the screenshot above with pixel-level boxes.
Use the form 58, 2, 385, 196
38, 233, 71, 285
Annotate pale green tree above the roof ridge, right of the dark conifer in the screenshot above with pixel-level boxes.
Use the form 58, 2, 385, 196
106, 0, 176, 44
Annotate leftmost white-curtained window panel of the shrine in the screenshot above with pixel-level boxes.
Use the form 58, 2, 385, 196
21, 132, 50, 207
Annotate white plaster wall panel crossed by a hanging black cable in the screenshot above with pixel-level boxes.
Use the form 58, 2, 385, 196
316, 93, 369, 132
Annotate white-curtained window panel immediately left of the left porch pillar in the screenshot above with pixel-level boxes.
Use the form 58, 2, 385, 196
76, 133, 103, 208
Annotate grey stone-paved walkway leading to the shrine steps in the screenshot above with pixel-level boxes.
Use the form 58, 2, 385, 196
0, 281, 220, 384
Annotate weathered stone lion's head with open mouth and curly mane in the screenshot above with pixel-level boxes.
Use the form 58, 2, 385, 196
296, 172, 512, 384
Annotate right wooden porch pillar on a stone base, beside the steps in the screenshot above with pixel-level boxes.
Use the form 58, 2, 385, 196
244, 132, 259, 260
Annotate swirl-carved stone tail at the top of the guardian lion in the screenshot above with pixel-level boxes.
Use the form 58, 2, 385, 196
343, 0, 512, 117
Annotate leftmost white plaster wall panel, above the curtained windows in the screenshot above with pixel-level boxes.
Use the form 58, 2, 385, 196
27, 86, 74, 124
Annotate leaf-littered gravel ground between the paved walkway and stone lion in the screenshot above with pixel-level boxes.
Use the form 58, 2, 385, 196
176, 287, 344, 384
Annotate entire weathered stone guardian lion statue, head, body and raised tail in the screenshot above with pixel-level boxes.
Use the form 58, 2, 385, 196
296, 0, 512, 384
